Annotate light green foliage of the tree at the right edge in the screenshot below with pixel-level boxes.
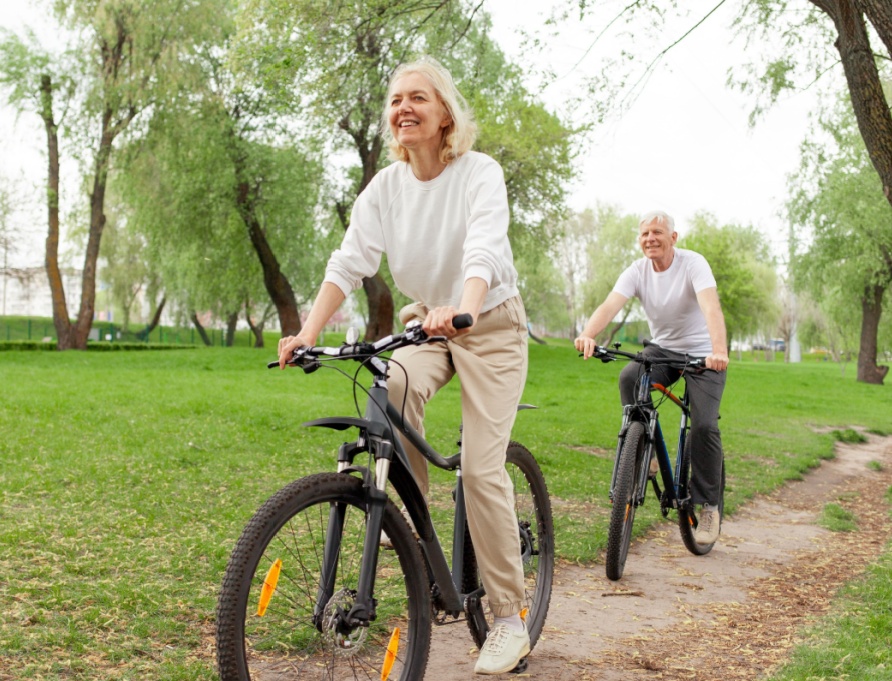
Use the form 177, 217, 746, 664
787, 92, 892, 360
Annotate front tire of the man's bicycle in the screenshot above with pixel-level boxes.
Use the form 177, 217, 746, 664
604, 421, 648, 581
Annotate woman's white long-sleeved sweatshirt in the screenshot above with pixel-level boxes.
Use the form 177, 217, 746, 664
325, 151, 518, 312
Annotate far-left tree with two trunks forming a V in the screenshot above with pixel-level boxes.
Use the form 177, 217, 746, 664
0, 0, 212, 350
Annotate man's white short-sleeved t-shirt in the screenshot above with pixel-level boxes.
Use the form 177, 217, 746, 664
613, 248, 716, 356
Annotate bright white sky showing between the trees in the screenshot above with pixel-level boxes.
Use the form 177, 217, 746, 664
0, 0, 817, 266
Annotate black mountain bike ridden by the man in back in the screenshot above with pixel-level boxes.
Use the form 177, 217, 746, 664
592, 343, 725, 580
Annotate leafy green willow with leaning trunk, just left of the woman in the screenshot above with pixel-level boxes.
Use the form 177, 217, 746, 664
113, 3, 328, 343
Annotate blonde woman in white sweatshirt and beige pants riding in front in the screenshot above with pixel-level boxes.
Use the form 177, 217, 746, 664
279, 59, 530, 674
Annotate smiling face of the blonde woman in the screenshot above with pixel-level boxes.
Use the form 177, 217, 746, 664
388, 73, 451, 153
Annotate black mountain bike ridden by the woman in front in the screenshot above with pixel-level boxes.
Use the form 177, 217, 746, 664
217, 317, 554, 681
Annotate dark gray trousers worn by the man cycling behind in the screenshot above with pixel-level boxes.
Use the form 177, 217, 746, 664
619, 345, 728, 505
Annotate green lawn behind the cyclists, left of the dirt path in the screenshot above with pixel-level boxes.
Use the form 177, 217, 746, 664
0, 337, 892, 681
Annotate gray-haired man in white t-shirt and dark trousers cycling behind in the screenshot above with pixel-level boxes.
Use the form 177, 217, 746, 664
575, 211, 728, 544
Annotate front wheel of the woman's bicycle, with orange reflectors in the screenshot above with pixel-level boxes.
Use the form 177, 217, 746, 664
216, 473, 431, 681
